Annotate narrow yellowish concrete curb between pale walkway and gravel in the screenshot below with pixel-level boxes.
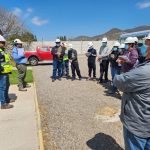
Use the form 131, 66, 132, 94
33, 82, 44, 150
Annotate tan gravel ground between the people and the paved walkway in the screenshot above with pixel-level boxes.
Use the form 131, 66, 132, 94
33, 56, 123, 150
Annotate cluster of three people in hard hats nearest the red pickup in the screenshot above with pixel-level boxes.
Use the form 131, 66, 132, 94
51, 39, 82, 82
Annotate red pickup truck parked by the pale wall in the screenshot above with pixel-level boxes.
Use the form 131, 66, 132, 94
25, 46, 53, 66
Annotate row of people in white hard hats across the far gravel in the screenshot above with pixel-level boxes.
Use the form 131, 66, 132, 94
51, 37, 146, 94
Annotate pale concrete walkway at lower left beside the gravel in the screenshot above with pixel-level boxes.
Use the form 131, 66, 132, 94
0, 84, 39, 150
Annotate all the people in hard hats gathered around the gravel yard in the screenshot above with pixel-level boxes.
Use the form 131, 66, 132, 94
0, 34, 150, 150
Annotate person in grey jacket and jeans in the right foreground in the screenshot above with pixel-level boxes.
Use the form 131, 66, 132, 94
114, 36, 150, 150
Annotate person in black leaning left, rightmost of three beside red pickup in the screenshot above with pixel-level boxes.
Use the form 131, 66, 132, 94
68, 44, 82, 81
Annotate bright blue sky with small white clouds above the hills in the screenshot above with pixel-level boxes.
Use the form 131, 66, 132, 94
0, 0, 150, 40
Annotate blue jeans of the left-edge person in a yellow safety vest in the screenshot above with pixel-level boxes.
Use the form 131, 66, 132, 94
0, 74, 10, 105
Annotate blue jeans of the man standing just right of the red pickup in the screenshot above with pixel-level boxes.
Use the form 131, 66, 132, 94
52, 60, 62, 80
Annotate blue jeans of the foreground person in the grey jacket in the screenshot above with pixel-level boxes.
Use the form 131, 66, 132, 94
123, 127, 150, 150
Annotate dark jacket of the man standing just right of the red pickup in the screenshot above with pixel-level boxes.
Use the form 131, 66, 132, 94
51, 46, 65, 61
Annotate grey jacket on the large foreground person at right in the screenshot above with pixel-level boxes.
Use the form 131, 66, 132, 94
113, 61, 150, 138
